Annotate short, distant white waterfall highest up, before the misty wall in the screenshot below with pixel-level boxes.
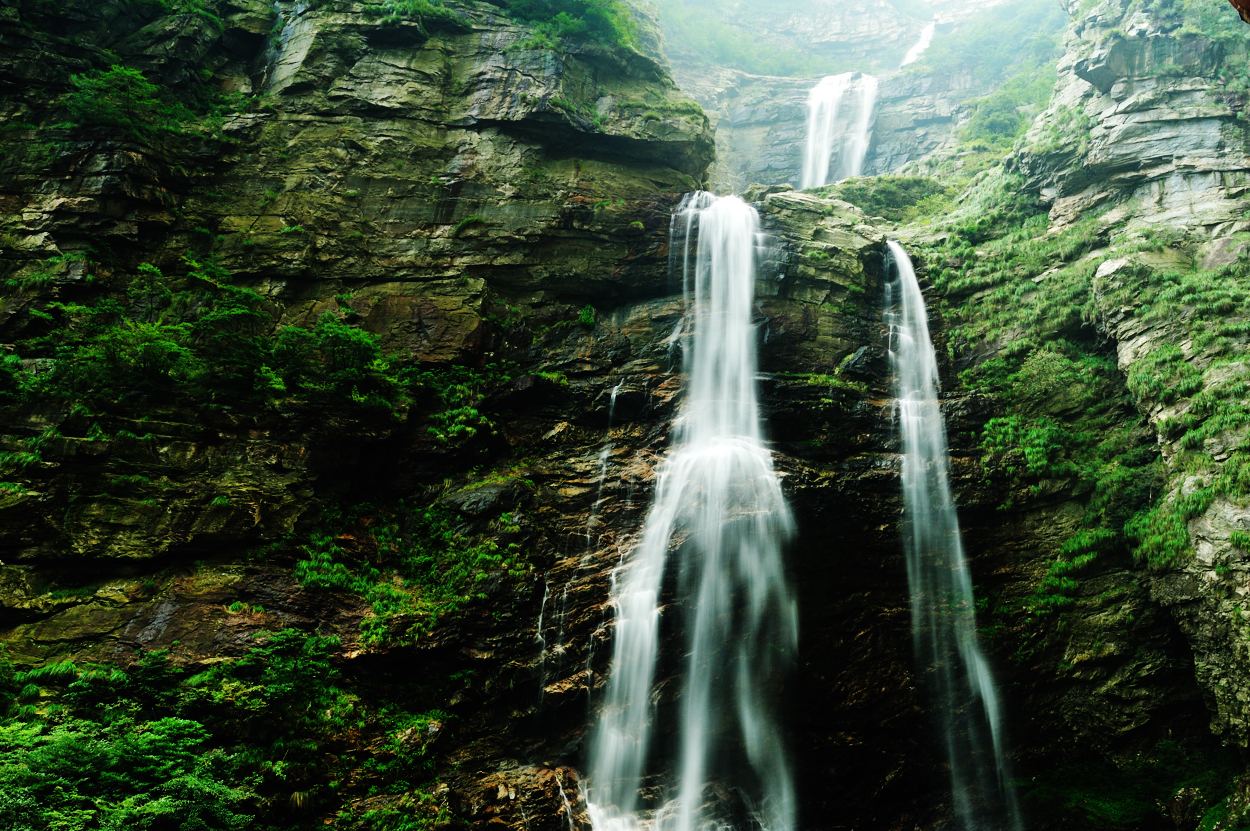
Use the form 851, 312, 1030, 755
803, 72, 878, 189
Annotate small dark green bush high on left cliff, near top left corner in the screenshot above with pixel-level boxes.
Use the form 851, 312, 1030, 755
61, 64, 194, 141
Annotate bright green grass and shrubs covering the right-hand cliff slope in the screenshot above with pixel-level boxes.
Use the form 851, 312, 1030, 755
930, 147, 1250, 589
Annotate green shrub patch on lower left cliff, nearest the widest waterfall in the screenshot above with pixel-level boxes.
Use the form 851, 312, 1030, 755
295, 505, 529, 646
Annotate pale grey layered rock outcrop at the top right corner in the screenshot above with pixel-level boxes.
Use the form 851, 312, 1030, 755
1016, 2, 1248, 239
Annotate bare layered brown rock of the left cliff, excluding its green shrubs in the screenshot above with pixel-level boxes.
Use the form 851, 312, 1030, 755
0, 0, 713, 829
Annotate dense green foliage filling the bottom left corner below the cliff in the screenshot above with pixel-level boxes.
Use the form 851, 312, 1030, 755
0, 630, 446, 831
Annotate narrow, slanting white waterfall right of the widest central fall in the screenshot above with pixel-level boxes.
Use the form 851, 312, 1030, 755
885, 241, 1020, 831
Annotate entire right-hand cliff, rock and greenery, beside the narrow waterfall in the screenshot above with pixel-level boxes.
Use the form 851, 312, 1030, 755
911, 2, 1246, 827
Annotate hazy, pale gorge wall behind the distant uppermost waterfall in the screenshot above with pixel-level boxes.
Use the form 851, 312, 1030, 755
660, 0, 1066, 190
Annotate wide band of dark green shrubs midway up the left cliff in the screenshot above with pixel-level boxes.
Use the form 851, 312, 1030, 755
0, 255, 408, 421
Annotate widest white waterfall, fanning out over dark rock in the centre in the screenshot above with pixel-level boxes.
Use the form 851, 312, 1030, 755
588, 194, 798, 831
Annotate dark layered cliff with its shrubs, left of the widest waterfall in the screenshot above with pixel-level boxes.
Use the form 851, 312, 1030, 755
0, 1, 711, 829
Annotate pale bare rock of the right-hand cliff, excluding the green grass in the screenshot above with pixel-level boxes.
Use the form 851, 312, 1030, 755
1015, 4, 1250, 746
